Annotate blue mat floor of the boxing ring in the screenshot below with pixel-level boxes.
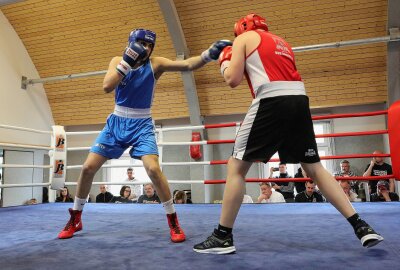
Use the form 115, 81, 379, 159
0, 202, 400, 270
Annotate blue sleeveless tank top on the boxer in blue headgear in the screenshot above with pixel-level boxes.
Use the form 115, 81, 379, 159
115, 61, 156, 109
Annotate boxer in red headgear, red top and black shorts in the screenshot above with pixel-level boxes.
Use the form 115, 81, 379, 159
194, 14, 383, 254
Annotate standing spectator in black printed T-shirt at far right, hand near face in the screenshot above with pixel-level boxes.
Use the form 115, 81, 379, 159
363, 150, 394, 194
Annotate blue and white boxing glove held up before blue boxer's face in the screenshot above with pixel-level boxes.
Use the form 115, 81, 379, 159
117, 42, 147, 77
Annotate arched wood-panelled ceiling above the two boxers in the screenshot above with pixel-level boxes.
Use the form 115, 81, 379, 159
0, 0, 387, 125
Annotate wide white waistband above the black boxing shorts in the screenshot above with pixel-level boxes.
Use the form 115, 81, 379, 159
255, 81, 306, 98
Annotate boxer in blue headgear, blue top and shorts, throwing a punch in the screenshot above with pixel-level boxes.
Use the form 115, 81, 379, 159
58, 29, 232, 242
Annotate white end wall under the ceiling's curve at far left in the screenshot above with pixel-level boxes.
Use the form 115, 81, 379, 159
0, 11, 54, 205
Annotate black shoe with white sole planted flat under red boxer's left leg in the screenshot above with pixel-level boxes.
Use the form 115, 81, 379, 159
193, 230, 236, 254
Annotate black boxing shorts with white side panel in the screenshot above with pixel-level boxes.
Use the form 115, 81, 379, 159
232, 95, 320, 163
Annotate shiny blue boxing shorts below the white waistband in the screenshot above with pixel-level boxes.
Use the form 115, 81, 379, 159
90, 114, 158, 159
